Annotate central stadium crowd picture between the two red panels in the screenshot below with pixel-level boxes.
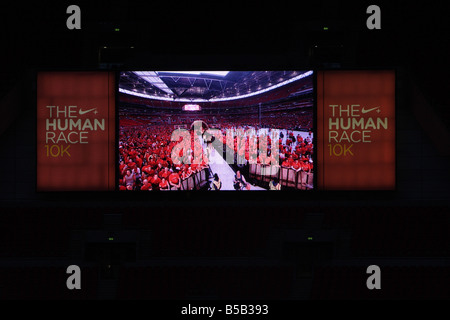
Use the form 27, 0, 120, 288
117, 70, 315, 192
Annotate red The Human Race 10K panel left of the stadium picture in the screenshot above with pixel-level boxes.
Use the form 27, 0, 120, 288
37, 72, 115, 191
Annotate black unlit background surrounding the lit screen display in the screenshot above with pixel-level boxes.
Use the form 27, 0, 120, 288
0, 0, 450, 301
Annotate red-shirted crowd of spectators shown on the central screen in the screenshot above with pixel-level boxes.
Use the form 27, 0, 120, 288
118, 119, 314, 191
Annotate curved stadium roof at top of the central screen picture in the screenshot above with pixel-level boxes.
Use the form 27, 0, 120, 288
119, 71, 313, 102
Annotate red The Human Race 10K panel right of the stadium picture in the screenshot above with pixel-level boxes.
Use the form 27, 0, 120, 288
317, 71, 395, 190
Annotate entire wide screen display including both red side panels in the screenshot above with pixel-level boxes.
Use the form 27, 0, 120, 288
36, 70, 396, 194
